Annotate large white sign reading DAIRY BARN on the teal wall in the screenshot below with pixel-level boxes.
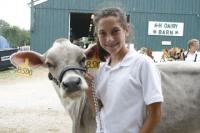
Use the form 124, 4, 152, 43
148, 21, 184, 36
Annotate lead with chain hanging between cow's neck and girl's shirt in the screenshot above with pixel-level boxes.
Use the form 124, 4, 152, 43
91, 80, 104, 133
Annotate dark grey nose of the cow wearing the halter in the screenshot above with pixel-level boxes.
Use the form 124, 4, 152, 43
62, 77, 81, 92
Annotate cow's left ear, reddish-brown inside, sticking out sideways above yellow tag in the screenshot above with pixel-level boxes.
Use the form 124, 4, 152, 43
10, 51, 45, 67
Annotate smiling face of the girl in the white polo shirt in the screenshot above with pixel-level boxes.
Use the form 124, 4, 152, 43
97, 16, 129, 54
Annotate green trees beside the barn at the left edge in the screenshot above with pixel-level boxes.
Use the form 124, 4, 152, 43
0, 20, 30, 48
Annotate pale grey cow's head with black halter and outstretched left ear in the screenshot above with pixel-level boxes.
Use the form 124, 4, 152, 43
11, 38, 97, 98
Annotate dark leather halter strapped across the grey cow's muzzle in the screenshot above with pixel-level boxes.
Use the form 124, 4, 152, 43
48, 65, 87, 87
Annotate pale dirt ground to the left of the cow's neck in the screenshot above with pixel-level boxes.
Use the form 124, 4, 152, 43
0, 68, 72, 133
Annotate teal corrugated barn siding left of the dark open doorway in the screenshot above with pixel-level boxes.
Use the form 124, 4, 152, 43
31, 2, 69, 53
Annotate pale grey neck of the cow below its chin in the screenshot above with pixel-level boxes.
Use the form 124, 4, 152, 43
55, 83, 96, 133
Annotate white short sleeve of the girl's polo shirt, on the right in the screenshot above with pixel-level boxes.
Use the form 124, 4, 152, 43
140, 58, 164, 105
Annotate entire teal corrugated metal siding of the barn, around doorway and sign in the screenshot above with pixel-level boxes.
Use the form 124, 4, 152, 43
31, 0, 200, 52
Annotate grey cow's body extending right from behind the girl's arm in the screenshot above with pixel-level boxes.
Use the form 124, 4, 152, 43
156, 62, 200, 133
